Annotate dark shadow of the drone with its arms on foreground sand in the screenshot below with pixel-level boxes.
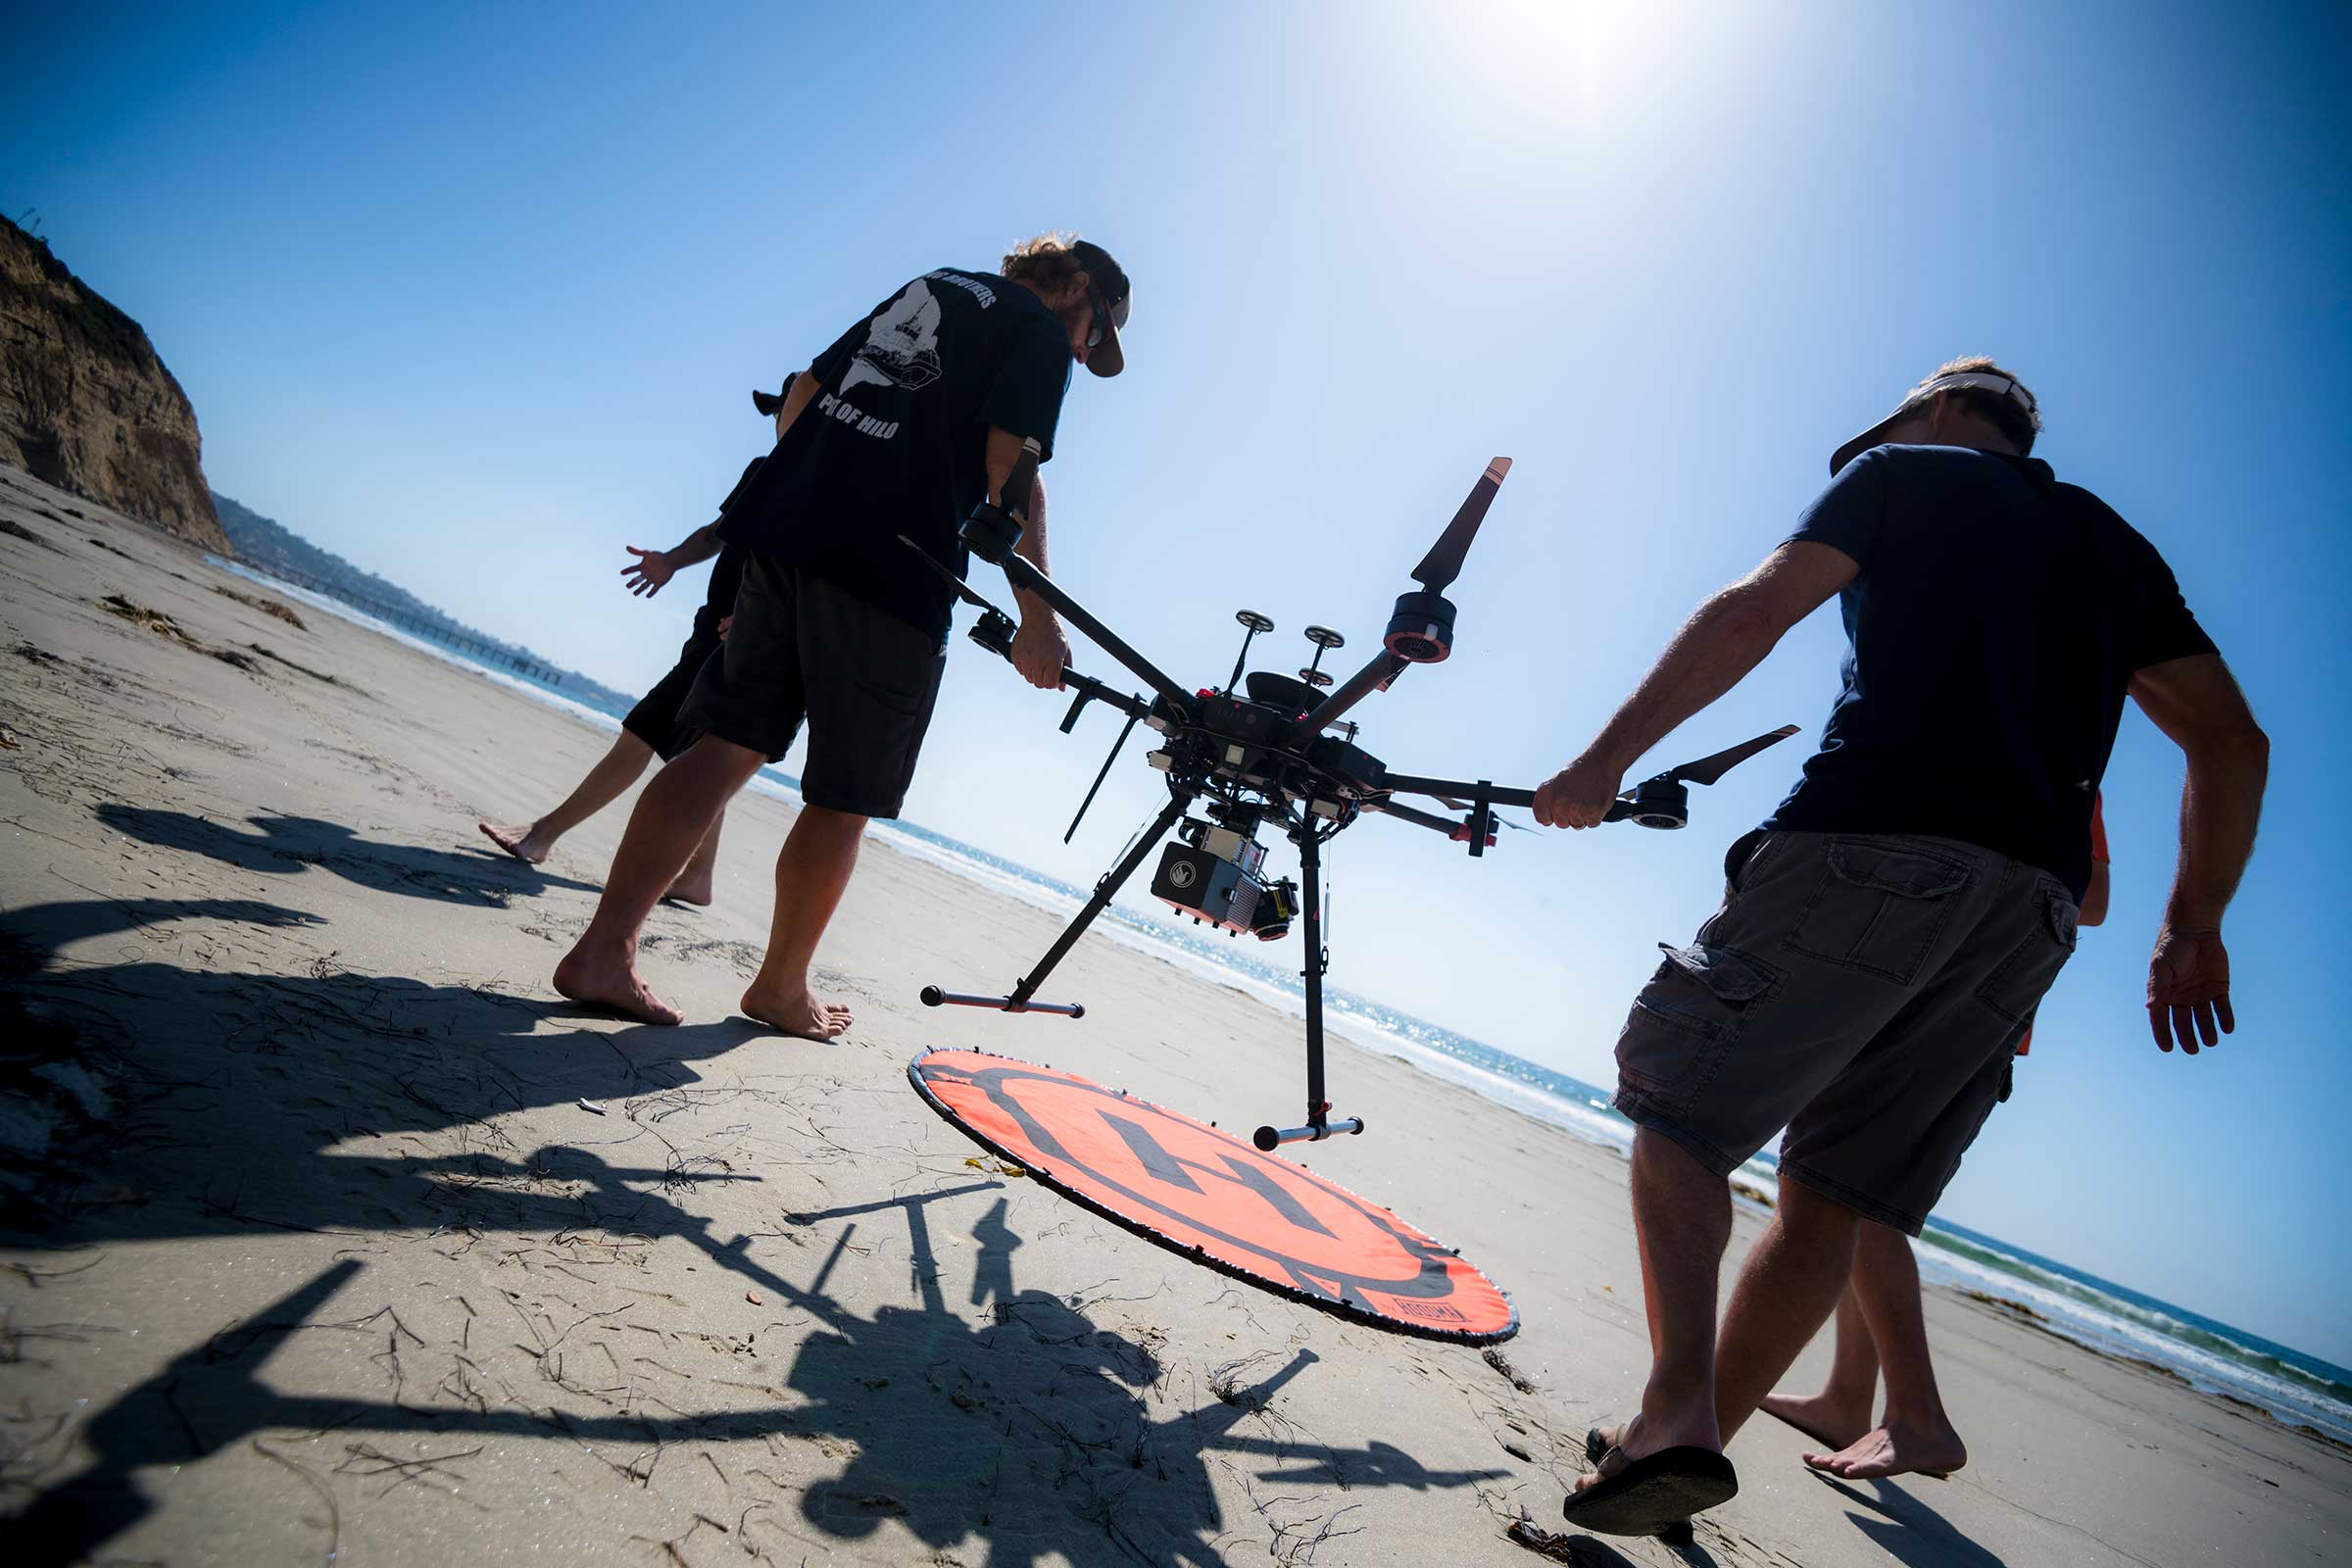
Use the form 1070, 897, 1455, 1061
10, 1170, 1503, 1568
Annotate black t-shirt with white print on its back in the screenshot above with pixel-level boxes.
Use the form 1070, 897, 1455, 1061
719, 268, 1072, 639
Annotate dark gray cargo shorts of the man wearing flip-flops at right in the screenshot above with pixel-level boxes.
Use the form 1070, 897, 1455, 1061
1616, 832, 2075, 1237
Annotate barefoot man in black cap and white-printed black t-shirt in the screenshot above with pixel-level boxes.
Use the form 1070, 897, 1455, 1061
555, 235, 1129, 1039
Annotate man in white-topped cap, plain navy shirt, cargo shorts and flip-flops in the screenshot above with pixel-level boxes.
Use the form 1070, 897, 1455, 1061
1536, 360, 2268, 1535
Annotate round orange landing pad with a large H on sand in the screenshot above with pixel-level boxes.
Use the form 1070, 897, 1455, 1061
906, 1051, 1519, 1345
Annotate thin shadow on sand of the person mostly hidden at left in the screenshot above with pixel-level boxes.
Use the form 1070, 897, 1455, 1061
96, 802, 598, 907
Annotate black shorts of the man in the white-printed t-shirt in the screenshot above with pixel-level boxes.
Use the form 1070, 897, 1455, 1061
680, 555, 948, 818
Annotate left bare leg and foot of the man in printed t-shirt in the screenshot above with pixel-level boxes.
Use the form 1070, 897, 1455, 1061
555, 736, 764, 1022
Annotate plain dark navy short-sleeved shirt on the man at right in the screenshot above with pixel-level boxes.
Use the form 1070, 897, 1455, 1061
1764, 447, 2216, 901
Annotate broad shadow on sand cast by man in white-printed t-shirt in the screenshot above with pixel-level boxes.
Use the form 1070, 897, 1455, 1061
0, 898, 761, 1246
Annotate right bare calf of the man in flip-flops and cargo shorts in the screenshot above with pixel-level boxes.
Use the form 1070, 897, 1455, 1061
1715, 1178, 1863, 1444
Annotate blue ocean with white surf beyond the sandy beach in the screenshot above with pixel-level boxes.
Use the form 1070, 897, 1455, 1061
214, 560, 2352, 1444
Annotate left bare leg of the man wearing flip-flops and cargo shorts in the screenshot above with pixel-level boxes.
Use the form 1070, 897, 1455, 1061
1576, 1126, 1731, 1491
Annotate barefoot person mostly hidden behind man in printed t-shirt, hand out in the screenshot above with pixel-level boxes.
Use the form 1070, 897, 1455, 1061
477, 371, 798, 906
